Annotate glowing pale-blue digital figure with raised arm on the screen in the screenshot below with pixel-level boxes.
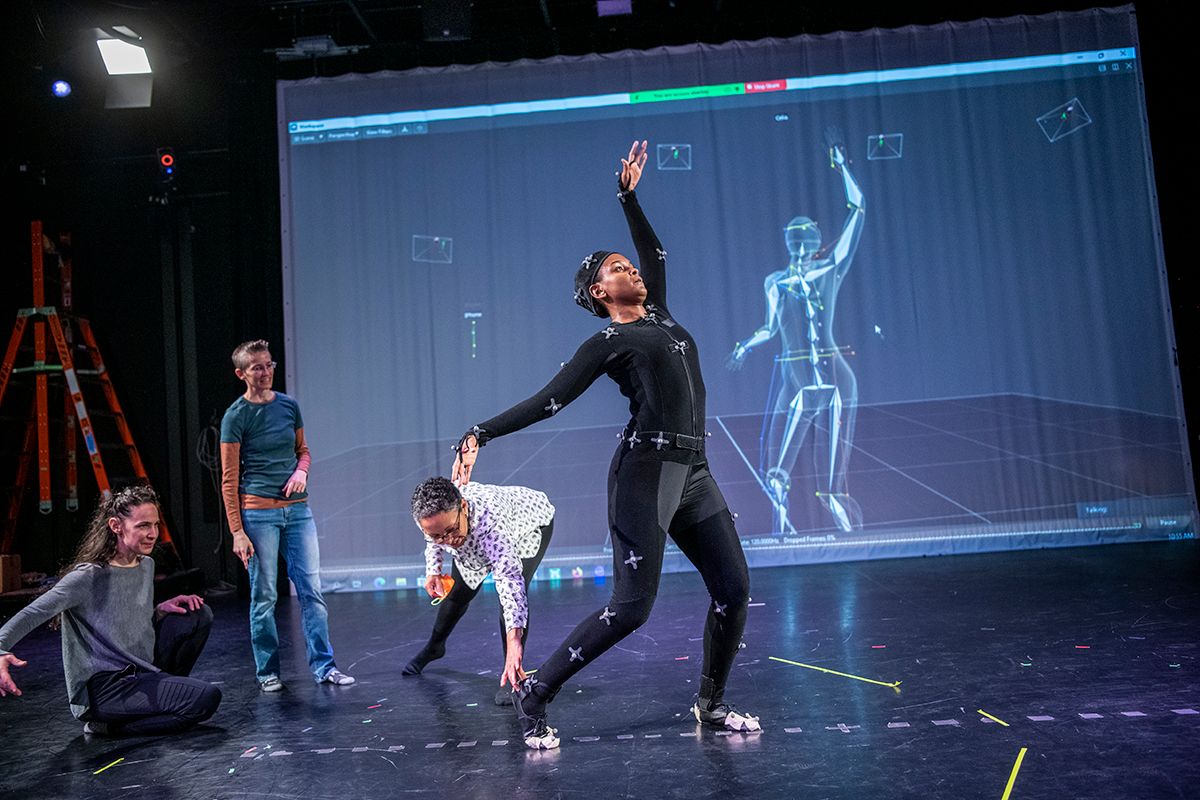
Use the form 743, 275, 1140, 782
728, 128, 865, 533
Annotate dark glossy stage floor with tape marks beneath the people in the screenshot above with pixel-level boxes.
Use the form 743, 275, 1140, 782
0, 542, 1200, 800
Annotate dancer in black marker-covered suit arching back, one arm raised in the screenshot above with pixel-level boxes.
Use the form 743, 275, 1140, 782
454, 142, 760, 748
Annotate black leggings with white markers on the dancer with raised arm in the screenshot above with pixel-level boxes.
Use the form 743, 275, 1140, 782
534, 449, 750, 702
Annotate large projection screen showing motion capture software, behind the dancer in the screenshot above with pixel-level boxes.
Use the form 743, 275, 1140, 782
276, 7, 1195, 590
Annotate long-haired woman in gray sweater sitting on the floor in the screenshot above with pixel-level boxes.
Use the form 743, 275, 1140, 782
0, 486, 221, 735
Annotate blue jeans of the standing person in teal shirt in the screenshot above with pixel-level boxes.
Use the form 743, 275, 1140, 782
241, 503, 335, 681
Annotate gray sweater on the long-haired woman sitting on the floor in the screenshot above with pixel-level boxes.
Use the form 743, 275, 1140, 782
0, 558, 158, 717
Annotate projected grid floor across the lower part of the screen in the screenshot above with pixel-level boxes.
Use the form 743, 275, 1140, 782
313, 395, 1190, 561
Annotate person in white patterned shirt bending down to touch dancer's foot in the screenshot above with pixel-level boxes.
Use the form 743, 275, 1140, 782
403, 477, 554, 705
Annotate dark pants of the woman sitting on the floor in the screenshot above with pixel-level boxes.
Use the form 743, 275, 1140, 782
84, 606, 221, 735
